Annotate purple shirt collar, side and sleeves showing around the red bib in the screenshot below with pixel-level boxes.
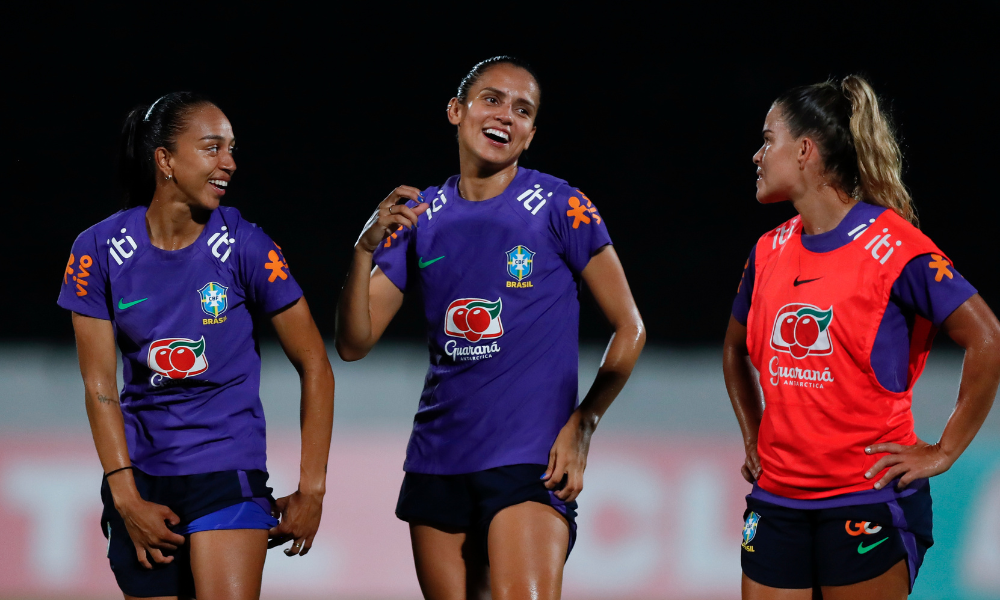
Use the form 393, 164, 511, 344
733, 202, 976, 392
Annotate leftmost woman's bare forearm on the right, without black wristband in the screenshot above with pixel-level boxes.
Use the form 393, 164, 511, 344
299, 360, 334, 494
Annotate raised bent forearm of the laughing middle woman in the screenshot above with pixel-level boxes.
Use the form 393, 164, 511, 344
336, 247, 375, 360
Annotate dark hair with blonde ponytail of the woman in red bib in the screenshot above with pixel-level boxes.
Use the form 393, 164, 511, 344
774, 75, 918, 225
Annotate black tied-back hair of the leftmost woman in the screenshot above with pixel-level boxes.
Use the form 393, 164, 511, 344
118, 92, 213, 208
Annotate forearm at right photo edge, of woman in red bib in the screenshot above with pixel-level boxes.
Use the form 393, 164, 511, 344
938, 344, 1000, 463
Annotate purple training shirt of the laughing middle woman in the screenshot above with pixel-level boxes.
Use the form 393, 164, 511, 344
374, 168, 611, 475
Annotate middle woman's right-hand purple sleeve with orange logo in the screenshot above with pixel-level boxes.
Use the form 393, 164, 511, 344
551, 186, 611, 275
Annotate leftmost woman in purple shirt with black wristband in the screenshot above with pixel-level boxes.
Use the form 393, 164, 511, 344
59, 92, 334, 599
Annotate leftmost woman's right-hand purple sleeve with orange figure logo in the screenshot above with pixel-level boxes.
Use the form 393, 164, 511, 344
240, 224, 302, 313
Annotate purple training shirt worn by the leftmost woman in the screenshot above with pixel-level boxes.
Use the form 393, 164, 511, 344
59, 206, 302, 476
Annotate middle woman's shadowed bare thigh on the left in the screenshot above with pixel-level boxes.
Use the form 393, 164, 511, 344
412, 523, 490, 600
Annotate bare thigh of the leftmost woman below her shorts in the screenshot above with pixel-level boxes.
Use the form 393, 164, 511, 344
189, 529, 267, 600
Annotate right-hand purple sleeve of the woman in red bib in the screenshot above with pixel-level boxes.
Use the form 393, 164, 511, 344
892, 254, 976, 327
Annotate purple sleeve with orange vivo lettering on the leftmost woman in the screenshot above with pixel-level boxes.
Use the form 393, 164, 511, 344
58, 229, 111, 321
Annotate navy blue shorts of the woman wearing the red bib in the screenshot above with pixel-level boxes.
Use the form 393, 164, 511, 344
741, 480, 934, 591
